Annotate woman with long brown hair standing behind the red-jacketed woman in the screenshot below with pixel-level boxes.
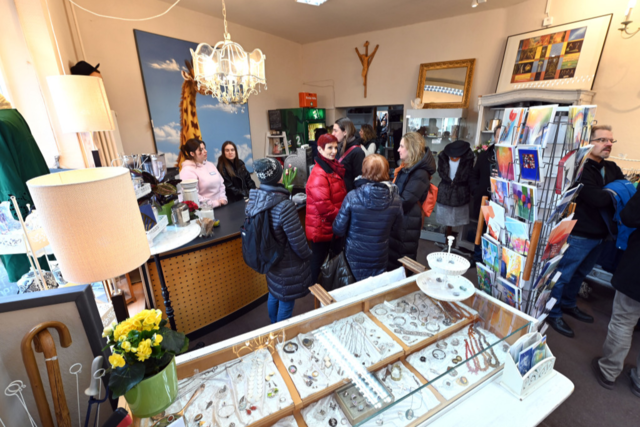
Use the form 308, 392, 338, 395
332, 117, 366, 192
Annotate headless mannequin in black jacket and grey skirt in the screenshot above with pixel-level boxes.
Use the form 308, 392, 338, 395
436, 140, 474, 235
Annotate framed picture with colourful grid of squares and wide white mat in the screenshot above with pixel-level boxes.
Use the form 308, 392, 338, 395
496, 14, 613, 93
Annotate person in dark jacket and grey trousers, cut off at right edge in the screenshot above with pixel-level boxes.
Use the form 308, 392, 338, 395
592, 192, 640, 397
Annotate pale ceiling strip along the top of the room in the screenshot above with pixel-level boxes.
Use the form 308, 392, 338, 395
162, 0, 527, 44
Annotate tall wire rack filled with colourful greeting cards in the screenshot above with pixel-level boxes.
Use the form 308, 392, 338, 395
475, 106, 596, 318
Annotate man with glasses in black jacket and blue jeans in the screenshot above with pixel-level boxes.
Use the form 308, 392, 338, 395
547, 125, 625, 338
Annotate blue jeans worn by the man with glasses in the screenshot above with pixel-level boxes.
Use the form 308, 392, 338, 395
549, 236, 602, 319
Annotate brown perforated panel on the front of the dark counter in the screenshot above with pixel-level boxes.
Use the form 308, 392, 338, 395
148, 238, 268, 334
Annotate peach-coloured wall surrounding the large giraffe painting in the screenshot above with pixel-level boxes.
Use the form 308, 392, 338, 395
67, 0, 301, 159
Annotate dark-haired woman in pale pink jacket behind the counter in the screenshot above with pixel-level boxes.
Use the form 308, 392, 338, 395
180, 138, 227, 208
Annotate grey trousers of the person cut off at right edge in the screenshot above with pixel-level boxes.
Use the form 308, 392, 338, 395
598, 292, 640, 387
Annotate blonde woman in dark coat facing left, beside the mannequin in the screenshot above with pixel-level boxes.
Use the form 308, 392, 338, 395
389, 132, 436, 270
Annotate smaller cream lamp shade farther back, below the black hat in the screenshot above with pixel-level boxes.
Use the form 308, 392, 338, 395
47, 75, 115, 133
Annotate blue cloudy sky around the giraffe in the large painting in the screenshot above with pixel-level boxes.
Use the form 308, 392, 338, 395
134, 30, 253, 172
